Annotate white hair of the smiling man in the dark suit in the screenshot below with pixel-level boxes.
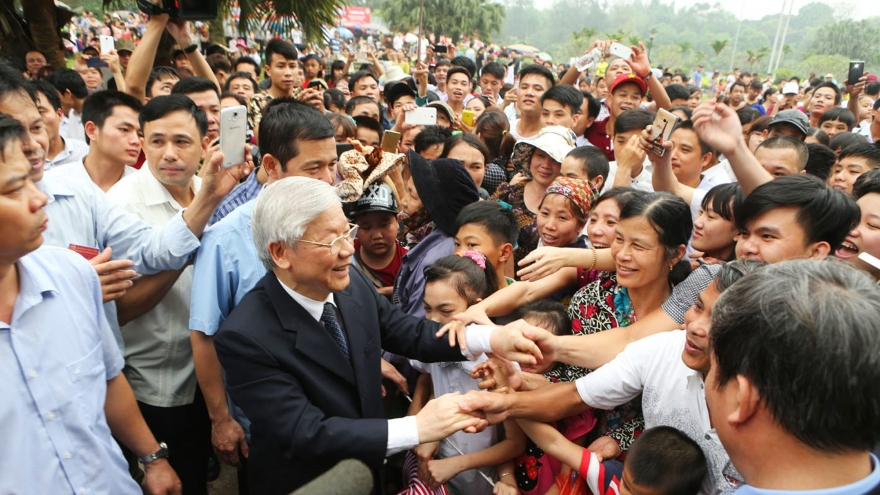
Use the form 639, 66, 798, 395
251, 177, 340, 271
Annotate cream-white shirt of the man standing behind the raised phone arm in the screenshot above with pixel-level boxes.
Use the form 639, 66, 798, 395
107, 164, 202, 407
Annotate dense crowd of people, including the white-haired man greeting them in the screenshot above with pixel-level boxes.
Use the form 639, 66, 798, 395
0, 4, 880, 495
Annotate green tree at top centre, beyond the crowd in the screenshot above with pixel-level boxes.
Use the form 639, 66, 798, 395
378, 0, 506, 40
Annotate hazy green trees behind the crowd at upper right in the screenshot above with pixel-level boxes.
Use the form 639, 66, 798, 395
498, 0, 880, 77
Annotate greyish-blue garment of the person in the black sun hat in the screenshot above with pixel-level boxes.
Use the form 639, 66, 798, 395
393, 227, 455, 318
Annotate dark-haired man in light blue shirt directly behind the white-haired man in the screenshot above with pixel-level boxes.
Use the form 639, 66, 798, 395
189, 98, 337, 476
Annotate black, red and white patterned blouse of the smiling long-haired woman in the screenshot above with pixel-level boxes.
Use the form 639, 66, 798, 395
545, 270, 645, 452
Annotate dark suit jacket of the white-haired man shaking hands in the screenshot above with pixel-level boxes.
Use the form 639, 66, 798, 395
214, 267, 464, 495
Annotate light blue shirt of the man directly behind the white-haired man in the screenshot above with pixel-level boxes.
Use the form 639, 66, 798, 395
189, 201, 266, 335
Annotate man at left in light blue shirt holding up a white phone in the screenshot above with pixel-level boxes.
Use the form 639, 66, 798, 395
0, 65, 252, 347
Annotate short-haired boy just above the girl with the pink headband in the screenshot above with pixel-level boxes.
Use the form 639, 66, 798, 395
454, 201, 519, 287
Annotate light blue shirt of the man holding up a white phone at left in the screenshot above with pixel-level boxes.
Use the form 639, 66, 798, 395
37, 172, 199, 349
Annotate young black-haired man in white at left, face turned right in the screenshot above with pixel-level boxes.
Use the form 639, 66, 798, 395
46, 90, 143, 192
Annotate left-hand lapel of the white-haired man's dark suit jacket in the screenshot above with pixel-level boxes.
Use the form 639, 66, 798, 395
264, 272, 357, 384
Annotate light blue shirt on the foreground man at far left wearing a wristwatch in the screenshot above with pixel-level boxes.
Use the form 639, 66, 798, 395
0, 247, 141, 495
